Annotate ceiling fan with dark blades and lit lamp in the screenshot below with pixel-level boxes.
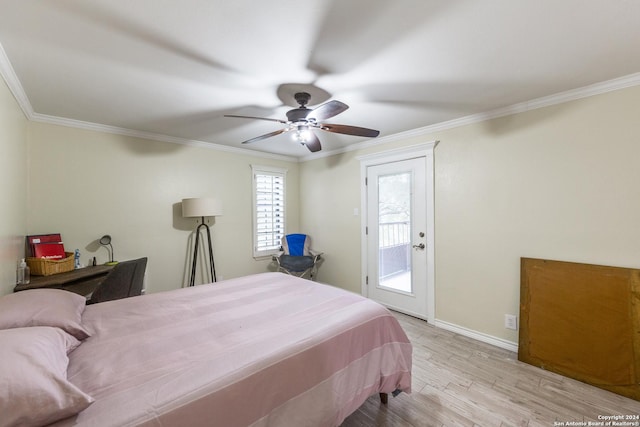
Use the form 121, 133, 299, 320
225, 92, 380, 153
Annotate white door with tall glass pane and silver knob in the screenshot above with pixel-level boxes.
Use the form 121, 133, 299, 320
367, 157, 428, 318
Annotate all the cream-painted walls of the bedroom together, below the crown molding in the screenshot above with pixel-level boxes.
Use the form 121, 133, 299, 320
5, 70, 640, 342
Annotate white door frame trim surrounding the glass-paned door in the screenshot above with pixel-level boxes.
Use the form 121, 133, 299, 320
357, 141, 439, 324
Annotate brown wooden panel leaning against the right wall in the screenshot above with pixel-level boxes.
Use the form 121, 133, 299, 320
518, 258, 640, 400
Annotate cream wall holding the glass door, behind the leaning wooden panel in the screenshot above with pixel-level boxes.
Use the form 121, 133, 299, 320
300, 87, 640, 342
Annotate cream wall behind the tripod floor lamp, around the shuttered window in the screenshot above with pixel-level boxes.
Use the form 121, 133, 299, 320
27, 122, 299, 292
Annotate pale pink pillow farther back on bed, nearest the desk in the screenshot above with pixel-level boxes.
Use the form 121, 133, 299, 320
0, 289, 91, 340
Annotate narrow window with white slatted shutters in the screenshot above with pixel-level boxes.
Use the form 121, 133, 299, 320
251, 165, 287, 257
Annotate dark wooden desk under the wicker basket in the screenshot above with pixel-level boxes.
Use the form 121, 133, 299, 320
13, 265, 114, 296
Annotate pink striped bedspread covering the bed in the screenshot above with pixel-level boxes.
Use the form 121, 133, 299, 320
50, 273, 412, 427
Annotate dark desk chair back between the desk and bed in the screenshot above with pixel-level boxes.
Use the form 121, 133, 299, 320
88, 258, 147, 304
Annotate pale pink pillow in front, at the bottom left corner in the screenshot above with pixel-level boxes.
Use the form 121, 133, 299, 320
0, 327, 94, 427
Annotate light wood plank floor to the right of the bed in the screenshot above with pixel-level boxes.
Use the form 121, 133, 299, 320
342, 313, 640, 427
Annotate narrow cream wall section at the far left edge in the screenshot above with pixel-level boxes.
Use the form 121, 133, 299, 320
0, 78, 28, 295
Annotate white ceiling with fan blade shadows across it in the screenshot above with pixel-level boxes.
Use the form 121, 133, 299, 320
0, 0, 640, 157
